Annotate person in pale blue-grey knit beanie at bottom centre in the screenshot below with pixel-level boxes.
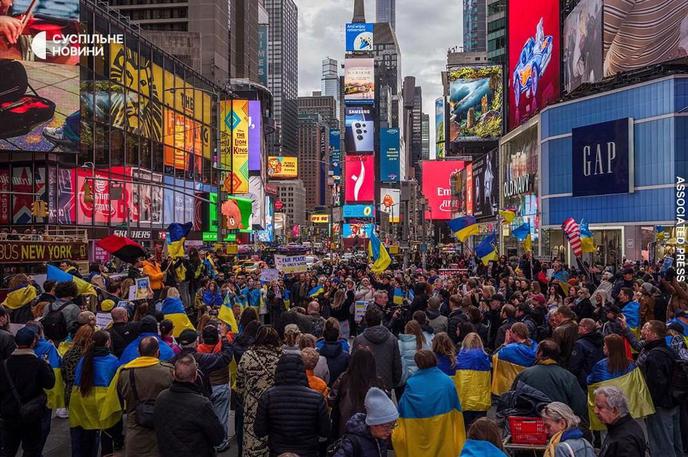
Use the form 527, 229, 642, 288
334, 387, 399, 457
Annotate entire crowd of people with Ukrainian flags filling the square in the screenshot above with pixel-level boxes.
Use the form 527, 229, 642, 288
0, 246, 688, 457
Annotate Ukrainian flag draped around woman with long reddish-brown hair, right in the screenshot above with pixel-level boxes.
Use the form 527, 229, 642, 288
588, 359, 655, 430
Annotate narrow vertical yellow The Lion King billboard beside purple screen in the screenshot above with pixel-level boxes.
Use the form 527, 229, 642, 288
220, 100, 250, 194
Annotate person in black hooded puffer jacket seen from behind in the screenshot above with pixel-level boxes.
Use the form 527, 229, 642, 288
253, 354, 330, 457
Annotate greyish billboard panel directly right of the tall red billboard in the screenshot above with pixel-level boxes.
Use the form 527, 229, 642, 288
562, 0, 602, 92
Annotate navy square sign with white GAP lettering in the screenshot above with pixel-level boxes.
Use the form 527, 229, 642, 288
571, 118, 633, 197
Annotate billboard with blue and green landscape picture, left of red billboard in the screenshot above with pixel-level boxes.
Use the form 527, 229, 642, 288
448, 65, 504, 142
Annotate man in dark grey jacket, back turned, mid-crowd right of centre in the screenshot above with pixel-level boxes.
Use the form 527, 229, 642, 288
352, 306, 401, 389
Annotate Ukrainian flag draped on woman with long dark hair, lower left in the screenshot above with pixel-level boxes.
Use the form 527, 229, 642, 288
69, 354, 122, 430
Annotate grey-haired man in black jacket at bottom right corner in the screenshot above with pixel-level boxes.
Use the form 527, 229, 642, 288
593, 386, 647, 457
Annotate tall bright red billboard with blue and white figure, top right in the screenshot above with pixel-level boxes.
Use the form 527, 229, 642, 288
507, 0, 560, 129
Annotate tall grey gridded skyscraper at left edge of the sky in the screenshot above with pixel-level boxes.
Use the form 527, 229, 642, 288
265, 0, 299, 154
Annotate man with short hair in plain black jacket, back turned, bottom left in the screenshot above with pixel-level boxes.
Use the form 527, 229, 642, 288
154, 355, 225, 457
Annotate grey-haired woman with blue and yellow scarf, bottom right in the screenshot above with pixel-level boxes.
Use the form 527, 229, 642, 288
540, 401, 595, 457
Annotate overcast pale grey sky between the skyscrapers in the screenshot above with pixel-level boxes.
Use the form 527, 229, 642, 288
295, 0, 463, 155
